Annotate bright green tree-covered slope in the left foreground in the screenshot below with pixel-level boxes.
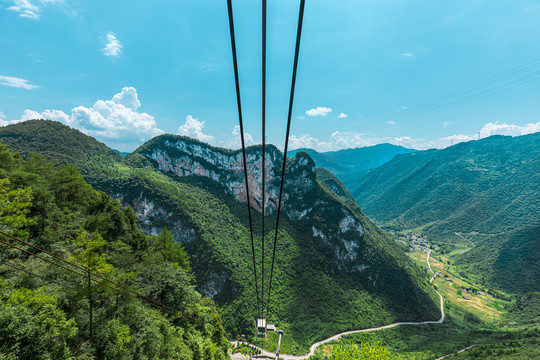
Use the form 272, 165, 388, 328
0, 142, 227, 359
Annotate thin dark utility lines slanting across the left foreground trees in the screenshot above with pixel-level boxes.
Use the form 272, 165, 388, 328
0, 231, 202, 325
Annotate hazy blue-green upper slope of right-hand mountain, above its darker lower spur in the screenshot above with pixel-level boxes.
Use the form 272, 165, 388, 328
345, 133, 540, 239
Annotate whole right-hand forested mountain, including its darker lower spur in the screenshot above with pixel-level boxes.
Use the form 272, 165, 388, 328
346, 133, 540, 292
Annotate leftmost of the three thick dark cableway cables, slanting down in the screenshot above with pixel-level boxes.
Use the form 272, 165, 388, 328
227, 0, 264, 314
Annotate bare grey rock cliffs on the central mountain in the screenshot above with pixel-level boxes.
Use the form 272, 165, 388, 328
136, 135, 369, 278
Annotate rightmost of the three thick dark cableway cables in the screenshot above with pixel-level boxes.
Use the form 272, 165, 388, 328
266, 0, 305, 318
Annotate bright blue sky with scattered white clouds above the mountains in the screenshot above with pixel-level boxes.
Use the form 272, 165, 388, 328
0, 0, 540, 151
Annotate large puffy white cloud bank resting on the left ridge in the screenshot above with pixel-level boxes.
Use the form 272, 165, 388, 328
0, 87, 163, 150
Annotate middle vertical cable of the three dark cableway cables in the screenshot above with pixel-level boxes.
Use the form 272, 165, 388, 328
261, 0, 266, 315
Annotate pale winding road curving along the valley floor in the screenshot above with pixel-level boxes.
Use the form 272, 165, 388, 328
231, 250, 445, 360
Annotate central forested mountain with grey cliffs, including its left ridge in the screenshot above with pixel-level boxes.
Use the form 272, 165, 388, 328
0, 121, 439, 351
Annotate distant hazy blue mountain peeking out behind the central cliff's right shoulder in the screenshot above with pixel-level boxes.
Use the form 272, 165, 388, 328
289, 144, 416, 181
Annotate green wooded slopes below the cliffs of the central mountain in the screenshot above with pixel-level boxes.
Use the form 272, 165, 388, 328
0, 123, 438, 352
